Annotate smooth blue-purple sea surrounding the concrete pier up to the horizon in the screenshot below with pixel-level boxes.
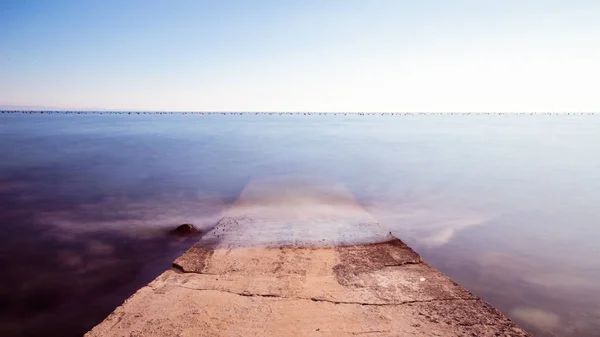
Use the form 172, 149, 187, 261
0, 114, 600, 336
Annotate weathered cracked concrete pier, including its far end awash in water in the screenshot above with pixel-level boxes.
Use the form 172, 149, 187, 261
87, 177, 528, 336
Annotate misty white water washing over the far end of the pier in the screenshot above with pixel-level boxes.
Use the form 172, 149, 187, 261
200, 176, 391, 247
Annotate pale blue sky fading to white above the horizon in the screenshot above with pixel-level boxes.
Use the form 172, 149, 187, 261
0, 0, 600, 112
